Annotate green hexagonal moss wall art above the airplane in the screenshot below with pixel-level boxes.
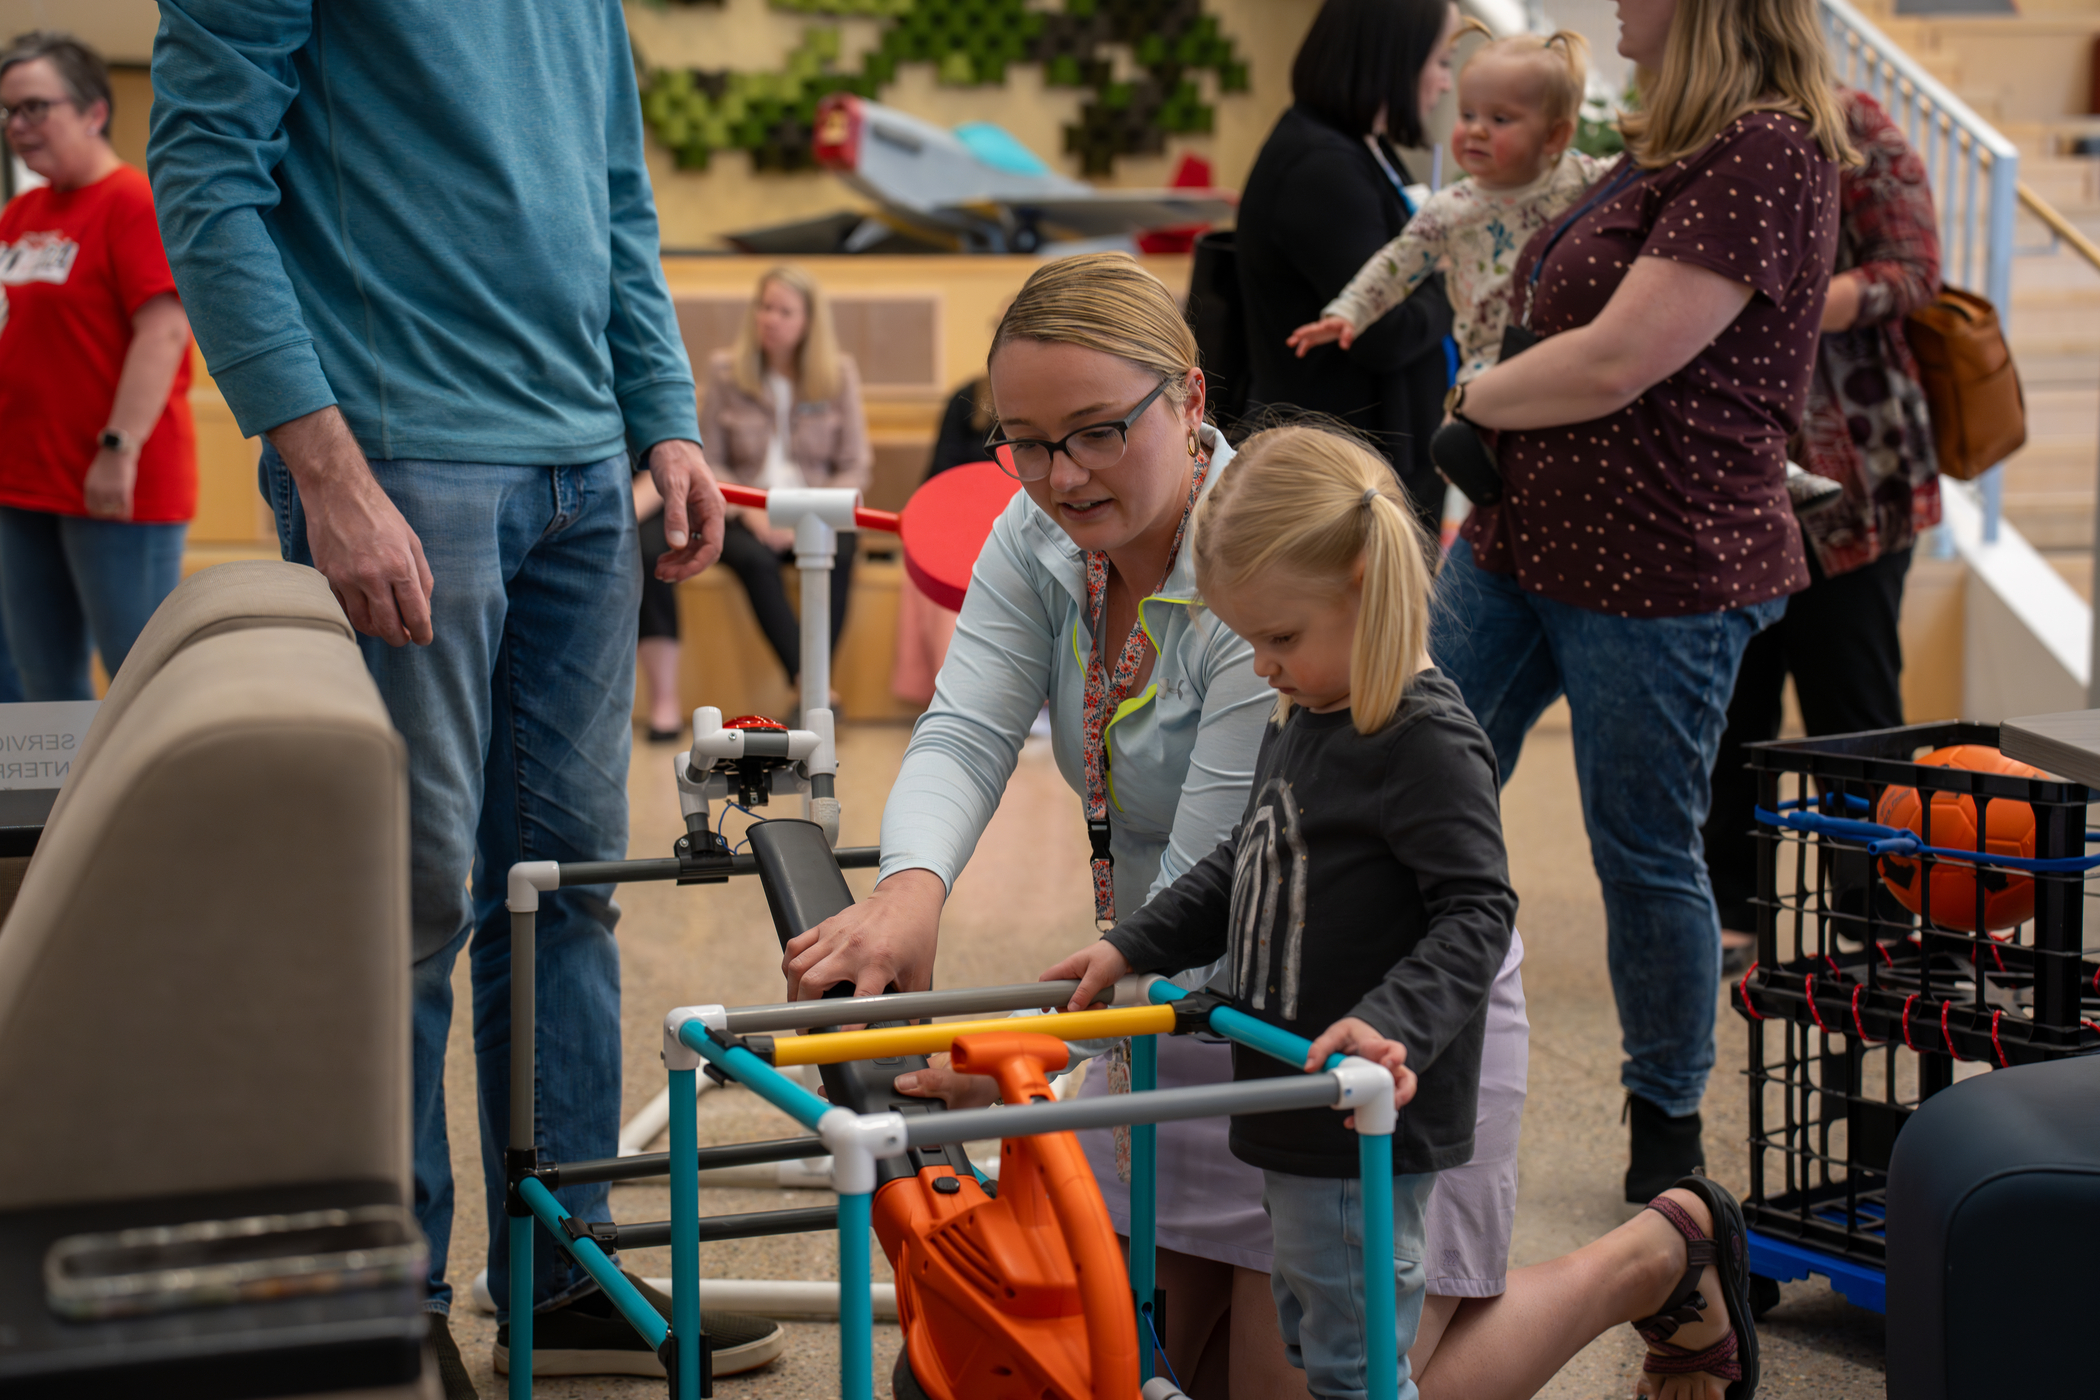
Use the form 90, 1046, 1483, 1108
641, 0, 1247, 176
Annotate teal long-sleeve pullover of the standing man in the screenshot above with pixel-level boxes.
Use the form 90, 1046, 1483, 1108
147, 0, 699, 466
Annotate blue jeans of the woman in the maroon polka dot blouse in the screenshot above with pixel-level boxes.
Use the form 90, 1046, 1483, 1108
1430, 539, 1787, 1117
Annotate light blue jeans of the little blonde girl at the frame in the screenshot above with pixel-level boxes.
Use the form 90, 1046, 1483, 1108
1262, 1171, 1436, 1400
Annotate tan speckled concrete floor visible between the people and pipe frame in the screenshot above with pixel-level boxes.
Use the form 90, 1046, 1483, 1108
430, 709, 1884, 1400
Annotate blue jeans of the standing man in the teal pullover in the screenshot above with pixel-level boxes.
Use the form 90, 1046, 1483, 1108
260, 447, 641, 1314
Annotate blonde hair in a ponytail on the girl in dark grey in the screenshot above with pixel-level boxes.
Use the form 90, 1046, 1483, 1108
1191, 426, 1430, 735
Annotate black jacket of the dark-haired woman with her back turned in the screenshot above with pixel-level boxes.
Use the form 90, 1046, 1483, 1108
1237, 105, 1451, 497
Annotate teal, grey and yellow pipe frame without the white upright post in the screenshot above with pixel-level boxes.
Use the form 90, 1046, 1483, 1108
504, 848, 1399, 1400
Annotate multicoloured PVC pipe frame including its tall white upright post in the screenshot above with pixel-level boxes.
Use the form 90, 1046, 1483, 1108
504, 487, 1399, 1400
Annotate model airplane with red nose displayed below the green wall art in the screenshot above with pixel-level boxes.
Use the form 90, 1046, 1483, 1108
729, 92, 1237, 254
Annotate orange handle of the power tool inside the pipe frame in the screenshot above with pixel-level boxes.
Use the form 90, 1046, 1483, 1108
949, 1031, 1138, 1400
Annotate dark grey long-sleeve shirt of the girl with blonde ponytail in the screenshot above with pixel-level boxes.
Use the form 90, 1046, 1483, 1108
1109, 672, 1516, 1178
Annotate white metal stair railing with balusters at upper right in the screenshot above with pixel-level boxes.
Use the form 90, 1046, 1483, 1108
1821, 0, 2015, 544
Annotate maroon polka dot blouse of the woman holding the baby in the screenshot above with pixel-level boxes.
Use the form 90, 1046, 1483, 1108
1466, 113, 1838, 617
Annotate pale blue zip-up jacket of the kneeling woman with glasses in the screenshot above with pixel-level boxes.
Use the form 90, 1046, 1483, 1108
882, 426, 1275, 931
